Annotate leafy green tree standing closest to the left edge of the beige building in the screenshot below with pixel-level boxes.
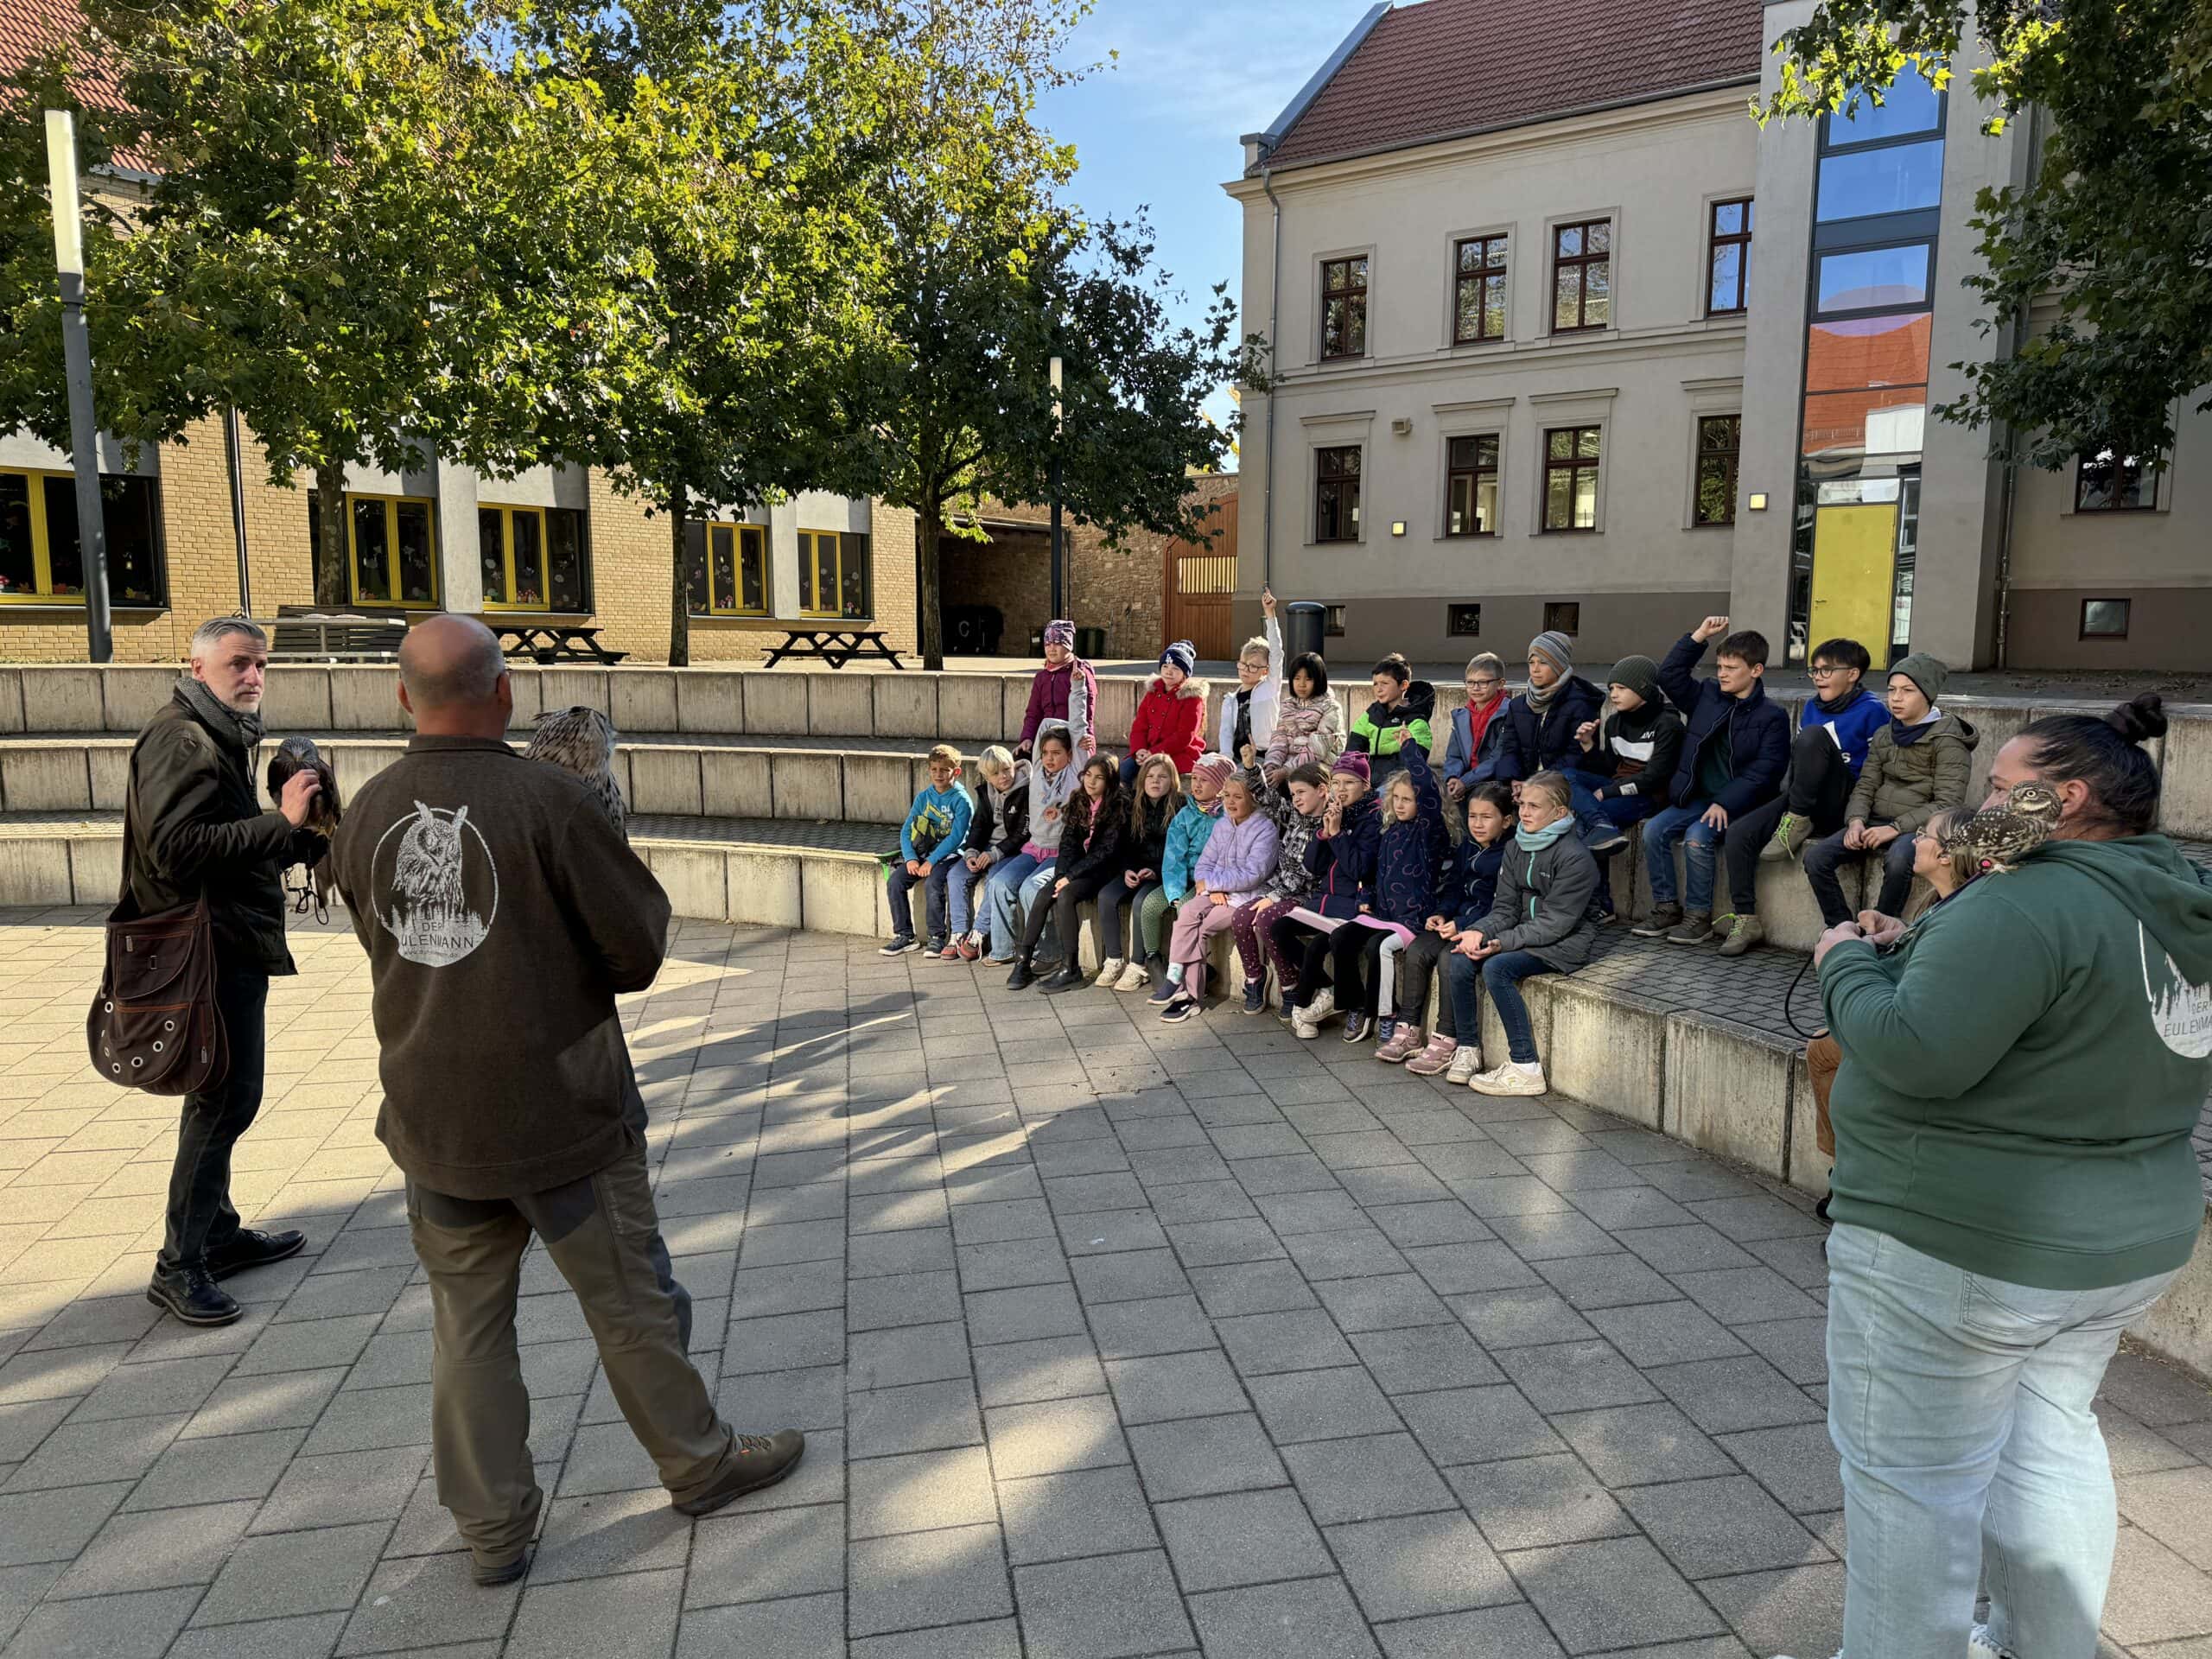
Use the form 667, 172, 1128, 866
791, 0, 1256, 668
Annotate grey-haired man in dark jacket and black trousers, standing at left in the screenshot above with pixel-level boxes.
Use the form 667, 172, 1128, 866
122, 617, 323, 1325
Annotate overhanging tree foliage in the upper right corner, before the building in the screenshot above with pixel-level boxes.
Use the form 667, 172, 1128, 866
1761, 0, 2212, 467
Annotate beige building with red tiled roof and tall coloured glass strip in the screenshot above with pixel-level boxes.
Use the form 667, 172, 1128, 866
1225, 0, 2212, 671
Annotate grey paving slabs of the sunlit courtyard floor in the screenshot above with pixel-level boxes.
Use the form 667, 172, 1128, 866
0, 912, 2212, 1659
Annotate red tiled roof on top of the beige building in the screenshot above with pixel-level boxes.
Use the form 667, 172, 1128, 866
1274, 0, 1761, 166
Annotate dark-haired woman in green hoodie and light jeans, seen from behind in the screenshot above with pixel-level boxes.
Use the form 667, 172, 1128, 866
1814, 695, 2212, 1659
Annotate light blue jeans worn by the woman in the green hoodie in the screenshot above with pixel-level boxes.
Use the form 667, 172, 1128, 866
1827, 1225, 2174, 1659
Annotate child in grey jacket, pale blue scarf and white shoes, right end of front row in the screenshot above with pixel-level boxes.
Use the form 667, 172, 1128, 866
1445, 772, 1597, 1095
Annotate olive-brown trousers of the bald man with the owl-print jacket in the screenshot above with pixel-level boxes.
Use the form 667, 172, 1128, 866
407, 1146, 736, 1566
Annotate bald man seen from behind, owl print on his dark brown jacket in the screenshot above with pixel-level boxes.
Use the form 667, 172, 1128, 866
334, 615, 805, 1584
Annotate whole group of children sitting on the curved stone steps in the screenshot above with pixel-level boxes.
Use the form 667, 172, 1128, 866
882, 593, 1975, 1095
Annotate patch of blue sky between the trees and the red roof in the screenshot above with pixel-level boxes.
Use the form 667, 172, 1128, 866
1042, 0, 1370, 468
